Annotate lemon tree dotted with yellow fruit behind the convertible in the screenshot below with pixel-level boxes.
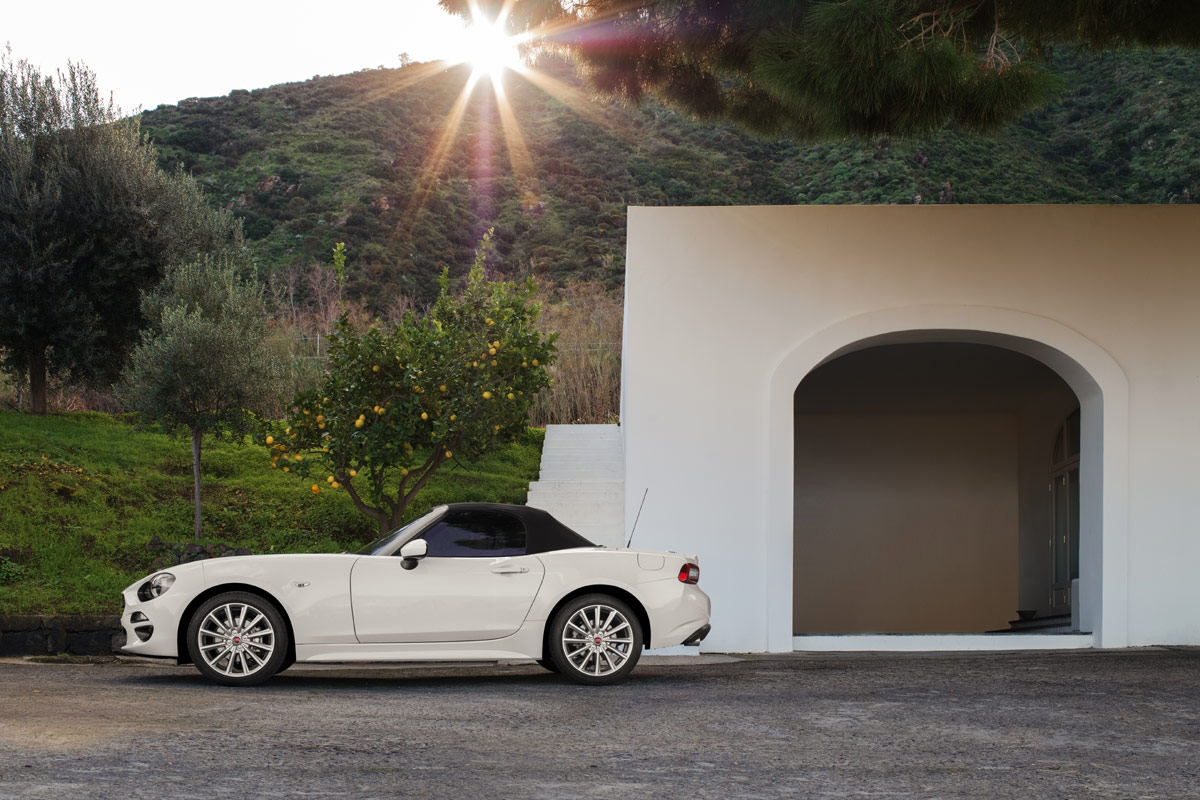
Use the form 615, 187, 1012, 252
265, 253, 554, 534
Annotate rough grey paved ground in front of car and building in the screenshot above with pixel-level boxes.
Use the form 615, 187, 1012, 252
0, 648, 1200, 799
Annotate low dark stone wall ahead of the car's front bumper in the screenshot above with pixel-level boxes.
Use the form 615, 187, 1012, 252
0, 614, 125, 656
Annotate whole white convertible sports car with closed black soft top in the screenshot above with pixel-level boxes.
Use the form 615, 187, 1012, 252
121, 503, 709, 686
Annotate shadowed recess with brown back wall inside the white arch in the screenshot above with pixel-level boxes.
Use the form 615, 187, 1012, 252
792, 342, 1080, 636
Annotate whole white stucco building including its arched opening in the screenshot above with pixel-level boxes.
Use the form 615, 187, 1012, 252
622, 206, 1200, 651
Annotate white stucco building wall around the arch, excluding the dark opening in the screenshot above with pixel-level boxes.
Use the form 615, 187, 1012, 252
623, 206, 1200, 651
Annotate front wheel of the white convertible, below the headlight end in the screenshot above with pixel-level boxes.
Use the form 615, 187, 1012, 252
187, 591, 289, 686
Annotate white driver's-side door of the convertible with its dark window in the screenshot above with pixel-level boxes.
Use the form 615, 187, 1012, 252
350, 511, 545, 643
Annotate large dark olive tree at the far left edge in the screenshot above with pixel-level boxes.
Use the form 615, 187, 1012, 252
0, 52, 241, 414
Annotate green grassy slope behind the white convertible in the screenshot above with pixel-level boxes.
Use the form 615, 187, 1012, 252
0, 411, 542, 614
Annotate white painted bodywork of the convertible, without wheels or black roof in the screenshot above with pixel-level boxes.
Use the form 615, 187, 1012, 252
121, 506, 710, 662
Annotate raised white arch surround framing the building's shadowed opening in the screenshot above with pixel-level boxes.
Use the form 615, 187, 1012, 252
762, 306, 1129, 651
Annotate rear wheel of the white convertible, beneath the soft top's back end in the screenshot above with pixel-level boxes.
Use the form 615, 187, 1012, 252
547, 594, 642, 686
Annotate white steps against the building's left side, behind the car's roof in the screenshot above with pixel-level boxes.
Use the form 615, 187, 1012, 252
526, 425, 625, 547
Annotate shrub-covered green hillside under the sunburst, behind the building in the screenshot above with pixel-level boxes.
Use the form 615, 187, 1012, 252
143, 52, 1200, 311
